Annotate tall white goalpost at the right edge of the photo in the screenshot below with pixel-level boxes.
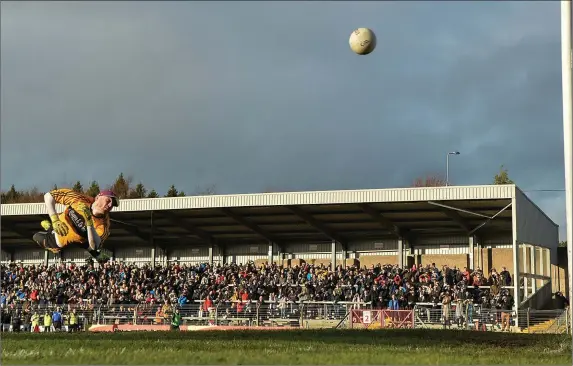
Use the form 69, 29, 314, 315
561, 0, 573, 333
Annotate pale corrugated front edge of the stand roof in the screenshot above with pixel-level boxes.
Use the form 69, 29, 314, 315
2, 185, 515, 216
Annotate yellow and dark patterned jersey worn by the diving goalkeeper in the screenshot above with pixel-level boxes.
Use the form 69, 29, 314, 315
50, 188, 109, 249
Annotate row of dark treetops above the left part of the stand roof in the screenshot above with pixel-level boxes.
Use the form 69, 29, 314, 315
1, 173, 217, 204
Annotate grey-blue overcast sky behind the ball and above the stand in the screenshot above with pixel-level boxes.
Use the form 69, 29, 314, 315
1, 1, 565, 240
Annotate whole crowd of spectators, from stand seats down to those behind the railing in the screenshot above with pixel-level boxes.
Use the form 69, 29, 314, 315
0, 261, 524, 328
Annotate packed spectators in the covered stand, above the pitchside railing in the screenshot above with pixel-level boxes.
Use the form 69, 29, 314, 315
0, 262, 511, 309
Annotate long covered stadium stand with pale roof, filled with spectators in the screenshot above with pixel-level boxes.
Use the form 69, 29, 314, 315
2, 185, 566, 330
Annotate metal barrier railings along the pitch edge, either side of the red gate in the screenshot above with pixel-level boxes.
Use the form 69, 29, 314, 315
0, 301, 571, 333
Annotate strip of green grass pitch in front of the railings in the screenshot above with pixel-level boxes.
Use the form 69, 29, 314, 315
2, 329, 572, 365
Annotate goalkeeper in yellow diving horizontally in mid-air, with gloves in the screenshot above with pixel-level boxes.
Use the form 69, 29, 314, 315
33, 189, 119, 262
